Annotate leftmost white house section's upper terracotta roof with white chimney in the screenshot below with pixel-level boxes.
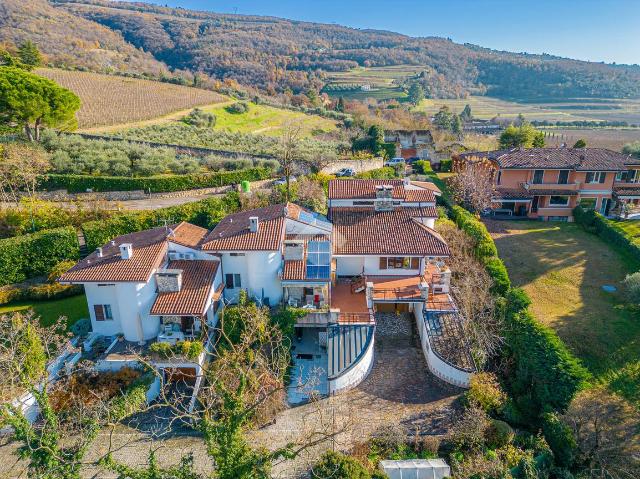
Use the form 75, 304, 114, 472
58, 226, 168, 283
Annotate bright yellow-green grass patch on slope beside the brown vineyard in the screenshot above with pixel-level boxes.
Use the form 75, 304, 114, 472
201, 104, 336, 137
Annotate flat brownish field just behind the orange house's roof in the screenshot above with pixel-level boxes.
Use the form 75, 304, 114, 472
541, 128, 640, 151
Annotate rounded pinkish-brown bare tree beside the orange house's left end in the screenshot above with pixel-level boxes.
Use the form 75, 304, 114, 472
447, 161, 495, 213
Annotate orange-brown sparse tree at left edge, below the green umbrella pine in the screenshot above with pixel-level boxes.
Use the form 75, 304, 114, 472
0, 143, 51, 204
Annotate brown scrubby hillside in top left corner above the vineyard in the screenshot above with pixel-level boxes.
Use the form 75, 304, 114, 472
0, 0, 168, 75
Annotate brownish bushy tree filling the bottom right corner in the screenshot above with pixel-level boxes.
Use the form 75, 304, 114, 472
562, 388, 640, 479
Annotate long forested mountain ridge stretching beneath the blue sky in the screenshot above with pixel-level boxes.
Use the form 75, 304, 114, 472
0, 0, 640, 99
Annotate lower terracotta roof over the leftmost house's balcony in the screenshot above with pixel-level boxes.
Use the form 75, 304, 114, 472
150, 260, 220, 316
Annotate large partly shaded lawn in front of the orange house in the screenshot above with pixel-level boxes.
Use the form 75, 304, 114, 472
487, 221, 640, 405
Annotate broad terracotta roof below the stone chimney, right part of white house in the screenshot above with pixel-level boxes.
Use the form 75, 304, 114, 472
331, 208, 449, 256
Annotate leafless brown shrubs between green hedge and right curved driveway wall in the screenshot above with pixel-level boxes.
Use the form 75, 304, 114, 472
438, 221, 504, 366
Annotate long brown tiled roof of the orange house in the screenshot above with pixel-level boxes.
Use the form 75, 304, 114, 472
459, 148, 640, 171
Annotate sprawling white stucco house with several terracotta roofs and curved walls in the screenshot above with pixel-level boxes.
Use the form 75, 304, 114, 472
60, 179, 473, 402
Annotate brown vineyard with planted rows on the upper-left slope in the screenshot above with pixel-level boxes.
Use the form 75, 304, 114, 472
36, 68, 226, 129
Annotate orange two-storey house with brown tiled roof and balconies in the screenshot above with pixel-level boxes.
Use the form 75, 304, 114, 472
453, 148, 640, 221
